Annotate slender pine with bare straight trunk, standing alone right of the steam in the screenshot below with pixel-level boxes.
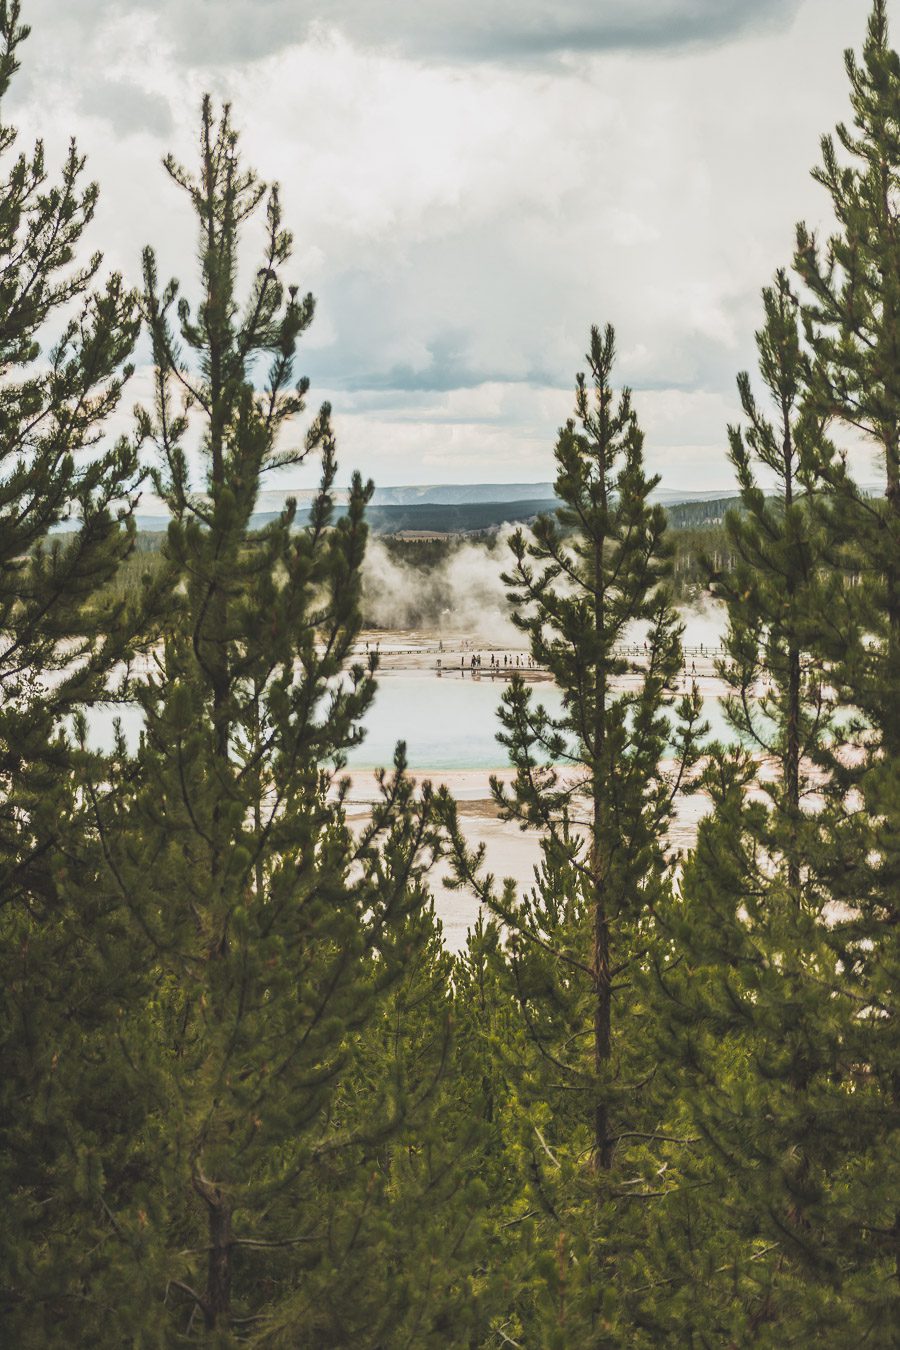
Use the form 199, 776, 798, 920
444, 328, 700, 1345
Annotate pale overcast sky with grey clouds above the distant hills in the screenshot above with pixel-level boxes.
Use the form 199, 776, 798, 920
4, 0, 869, 489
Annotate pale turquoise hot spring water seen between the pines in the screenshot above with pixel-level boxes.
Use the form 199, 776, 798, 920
82, 672, 726, 770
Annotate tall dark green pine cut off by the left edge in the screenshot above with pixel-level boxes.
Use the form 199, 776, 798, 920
0, 0, 148, 1346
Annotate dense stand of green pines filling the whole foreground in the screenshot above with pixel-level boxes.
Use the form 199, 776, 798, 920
0, 0, 900, 1350
